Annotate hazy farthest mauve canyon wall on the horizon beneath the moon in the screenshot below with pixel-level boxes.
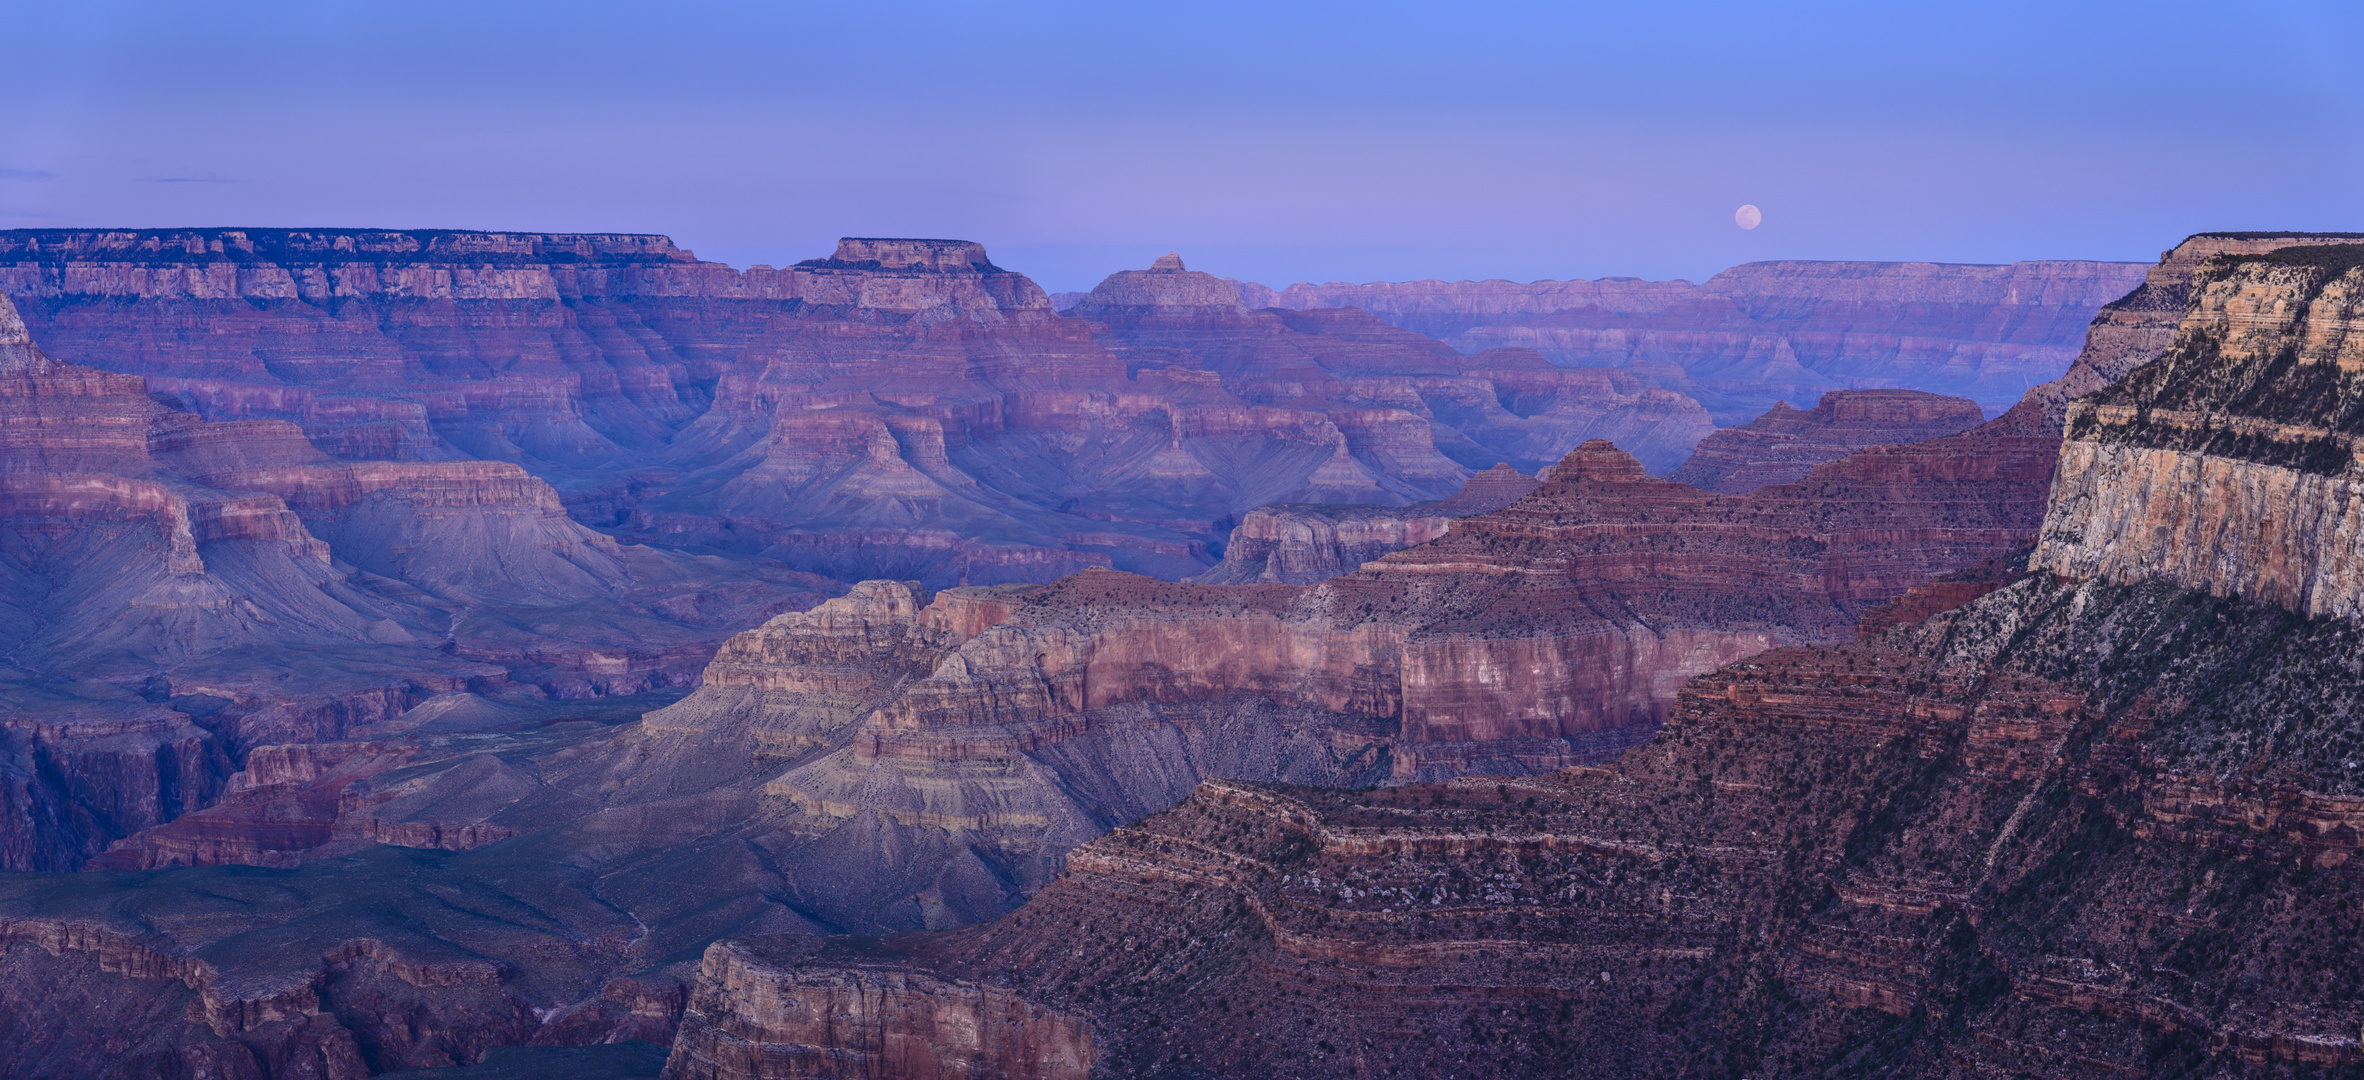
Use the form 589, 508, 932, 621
1239, 260, 2144, 425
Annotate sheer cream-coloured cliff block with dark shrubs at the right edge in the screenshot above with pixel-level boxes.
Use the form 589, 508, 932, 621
2033, 236, 2364, 617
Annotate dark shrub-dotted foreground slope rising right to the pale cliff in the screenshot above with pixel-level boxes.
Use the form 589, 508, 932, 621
664, 236, 2364, 1080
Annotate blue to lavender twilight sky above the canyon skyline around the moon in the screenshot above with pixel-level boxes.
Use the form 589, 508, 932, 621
0, 0, 2364, 291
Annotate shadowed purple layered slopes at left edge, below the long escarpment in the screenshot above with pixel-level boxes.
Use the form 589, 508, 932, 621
0, 288, 830, 870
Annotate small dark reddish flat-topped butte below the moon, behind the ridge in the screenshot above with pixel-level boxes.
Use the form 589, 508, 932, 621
1667, 390, 1986, 494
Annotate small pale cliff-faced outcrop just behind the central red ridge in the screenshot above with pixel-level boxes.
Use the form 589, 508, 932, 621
1191, 463, 1539, 586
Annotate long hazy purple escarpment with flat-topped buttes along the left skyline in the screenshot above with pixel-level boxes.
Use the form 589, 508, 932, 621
0, 229, 1709, 586
